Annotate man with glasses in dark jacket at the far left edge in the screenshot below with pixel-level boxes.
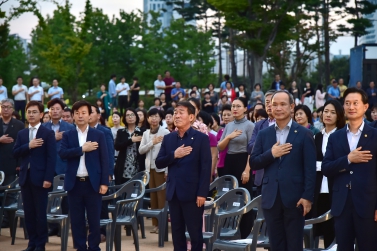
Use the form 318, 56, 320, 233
0, 99, 25, 227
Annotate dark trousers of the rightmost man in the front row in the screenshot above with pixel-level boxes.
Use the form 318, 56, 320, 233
334, 191, 377, 251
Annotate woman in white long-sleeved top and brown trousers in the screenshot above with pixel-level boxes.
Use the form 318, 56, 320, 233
139, 108, 170, 233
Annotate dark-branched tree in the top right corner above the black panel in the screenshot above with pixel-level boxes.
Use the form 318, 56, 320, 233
338, 0, 377, 46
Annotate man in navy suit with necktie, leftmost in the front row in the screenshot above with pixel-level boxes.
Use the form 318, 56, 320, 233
13, 101, 56, 251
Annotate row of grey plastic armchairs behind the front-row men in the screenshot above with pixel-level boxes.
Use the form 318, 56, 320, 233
0, 172, 338, 251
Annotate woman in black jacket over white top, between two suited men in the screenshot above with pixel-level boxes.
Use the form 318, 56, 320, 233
309, 100, 346, 248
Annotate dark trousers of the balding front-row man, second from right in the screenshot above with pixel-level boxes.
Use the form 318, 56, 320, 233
263, 190, 304, 251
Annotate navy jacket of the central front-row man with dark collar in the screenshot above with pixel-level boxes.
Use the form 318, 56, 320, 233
155, 127, 212, 201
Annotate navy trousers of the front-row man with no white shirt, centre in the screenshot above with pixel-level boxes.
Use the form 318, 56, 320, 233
169, 193, 204, 251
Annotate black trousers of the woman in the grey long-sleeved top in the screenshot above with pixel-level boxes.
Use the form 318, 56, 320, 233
223, 153, 255, 239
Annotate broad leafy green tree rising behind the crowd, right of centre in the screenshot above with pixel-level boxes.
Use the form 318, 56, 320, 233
208, 0, 303, 89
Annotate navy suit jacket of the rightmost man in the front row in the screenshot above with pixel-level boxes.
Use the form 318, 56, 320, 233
322, 123, 377, 218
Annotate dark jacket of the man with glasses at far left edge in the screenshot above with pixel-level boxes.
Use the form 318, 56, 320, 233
0, 118, 25, 175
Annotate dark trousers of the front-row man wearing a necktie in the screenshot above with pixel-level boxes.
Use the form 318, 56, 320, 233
21, 171, 50, 248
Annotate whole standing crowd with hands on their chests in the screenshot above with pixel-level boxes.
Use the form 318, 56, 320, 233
0, 71, 377, 251
